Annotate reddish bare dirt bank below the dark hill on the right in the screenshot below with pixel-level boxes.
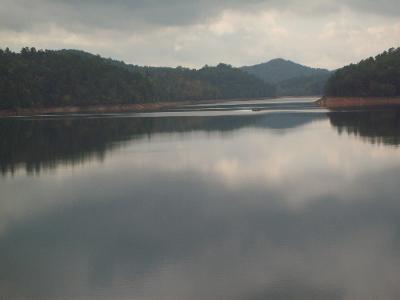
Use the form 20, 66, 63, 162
317, 97, 400, 109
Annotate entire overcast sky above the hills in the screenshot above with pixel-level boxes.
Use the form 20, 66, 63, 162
0, 0, 400, 69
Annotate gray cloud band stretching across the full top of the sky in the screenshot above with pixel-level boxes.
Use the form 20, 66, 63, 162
0, 0, 400, 31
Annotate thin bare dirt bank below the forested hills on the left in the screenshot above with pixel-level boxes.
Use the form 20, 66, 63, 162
0, 102, 184, 116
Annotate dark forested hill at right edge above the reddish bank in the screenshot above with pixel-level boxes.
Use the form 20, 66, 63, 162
325, 48, 400, 97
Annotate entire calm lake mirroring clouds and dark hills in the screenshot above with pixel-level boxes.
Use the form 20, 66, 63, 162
0, 98, 400, 300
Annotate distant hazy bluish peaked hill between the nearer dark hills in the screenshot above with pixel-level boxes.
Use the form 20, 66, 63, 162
241, 58, 331, 96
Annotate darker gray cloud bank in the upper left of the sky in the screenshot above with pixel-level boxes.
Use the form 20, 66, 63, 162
0, 0, 253, 31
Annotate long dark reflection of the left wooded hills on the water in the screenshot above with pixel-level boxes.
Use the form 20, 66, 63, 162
0, 113, 322, 175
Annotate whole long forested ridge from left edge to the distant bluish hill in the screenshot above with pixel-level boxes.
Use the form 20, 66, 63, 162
0, 48, 275, 109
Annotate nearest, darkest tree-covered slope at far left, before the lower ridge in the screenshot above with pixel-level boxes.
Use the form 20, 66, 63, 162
0, 48, 153, 108
